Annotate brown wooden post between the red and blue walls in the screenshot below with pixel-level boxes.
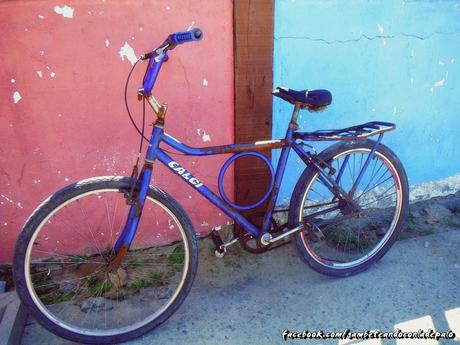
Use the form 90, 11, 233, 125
234, 0, 274, 231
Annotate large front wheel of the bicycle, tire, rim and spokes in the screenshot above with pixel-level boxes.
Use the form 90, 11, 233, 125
14, 177, 198, 344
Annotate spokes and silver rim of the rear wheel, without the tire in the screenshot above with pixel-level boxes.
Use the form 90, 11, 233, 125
299, 148, 401, 272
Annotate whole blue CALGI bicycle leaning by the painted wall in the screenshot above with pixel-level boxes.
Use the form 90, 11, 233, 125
14, 29, 408, 344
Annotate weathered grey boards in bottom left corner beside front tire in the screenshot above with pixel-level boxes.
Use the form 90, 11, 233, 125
0, 291, 27, 345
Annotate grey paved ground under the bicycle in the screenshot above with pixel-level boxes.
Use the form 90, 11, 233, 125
18, 195, 460, 345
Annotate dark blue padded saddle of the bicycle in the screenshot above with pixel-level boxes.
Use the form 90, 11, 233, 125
272, 87, 332, 111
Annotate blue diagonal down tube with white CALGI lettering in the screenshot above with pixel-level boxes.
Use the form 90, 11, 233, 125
157, 149, 260, 237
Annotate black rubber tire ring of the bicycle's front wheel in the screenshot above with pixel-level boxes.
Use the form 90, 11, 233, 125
13, 177, 198, 344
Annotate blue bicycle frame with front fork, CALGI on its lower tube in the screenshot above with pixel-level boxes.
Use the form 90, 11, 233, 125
115, 115, 383, 250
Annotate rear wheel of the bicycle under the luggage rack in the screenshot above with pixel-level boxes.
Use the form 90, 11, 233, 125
289, 140, 408, 277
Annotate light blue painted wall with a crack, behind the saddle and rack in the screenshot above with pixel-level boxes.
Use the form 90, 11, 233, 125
273, 0, 460, 203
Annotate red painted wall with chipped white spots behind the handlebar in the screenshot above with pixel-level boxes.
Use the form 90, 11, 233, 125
0, 0, 233, 263
